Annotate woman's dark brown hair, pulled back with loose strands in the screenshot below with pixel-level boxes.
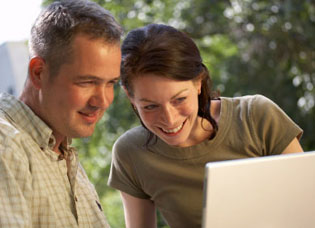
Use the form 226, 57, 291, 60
121, 24, 218, 145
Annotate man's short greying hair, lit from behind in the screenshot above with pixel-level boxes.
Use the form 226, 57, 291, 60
29, 0, 122, 75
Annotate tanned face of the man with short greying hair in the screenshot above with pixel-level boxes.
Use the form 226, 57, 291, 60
40, 35, 121, 140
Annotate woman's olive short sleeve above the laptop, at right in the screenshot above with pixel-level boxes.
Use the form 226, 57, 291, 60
250, 95, 303, 155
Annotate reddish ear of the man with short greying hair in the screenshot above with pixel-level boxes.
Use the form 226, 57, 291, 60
29, 56, 47, 89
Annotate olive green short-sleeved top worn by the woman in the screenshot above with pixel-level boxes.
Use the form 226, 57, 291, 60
108, 95, 302, 228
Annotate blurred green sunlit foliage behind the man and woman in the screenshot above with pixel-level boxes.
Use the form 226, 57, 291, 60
1, 0, 315, 228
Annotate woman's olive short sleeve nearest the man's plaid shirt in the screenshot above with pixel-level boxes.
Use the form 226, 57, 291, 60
108, 132, 149, 199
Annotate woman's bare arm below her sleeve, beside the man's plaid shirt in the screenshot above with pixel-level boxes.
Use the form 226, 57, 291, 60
120, 192, 156, 228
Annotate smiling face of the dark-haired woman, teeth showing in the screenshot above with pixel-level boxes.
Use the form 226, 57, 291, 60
129, 74, 202, 147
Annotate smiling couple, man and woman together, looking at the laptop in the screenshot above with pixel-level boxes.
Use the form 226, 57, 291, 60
0, 0, 303, 228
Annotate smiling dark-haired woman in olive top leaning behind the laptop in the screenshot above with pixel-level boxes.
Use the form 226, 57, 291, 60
109, 24, 303, 228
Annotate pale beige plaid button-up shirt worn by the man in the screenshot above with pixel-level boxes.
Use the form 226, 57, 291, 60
0, 94, 109, 228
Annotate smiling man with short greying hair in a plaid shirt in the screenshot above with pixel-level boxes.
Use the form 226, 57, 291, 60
0, 0, 122, 227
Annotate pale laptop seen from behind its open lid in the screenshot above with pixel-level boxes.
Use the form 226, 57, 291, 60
202, 151, 315, 228
